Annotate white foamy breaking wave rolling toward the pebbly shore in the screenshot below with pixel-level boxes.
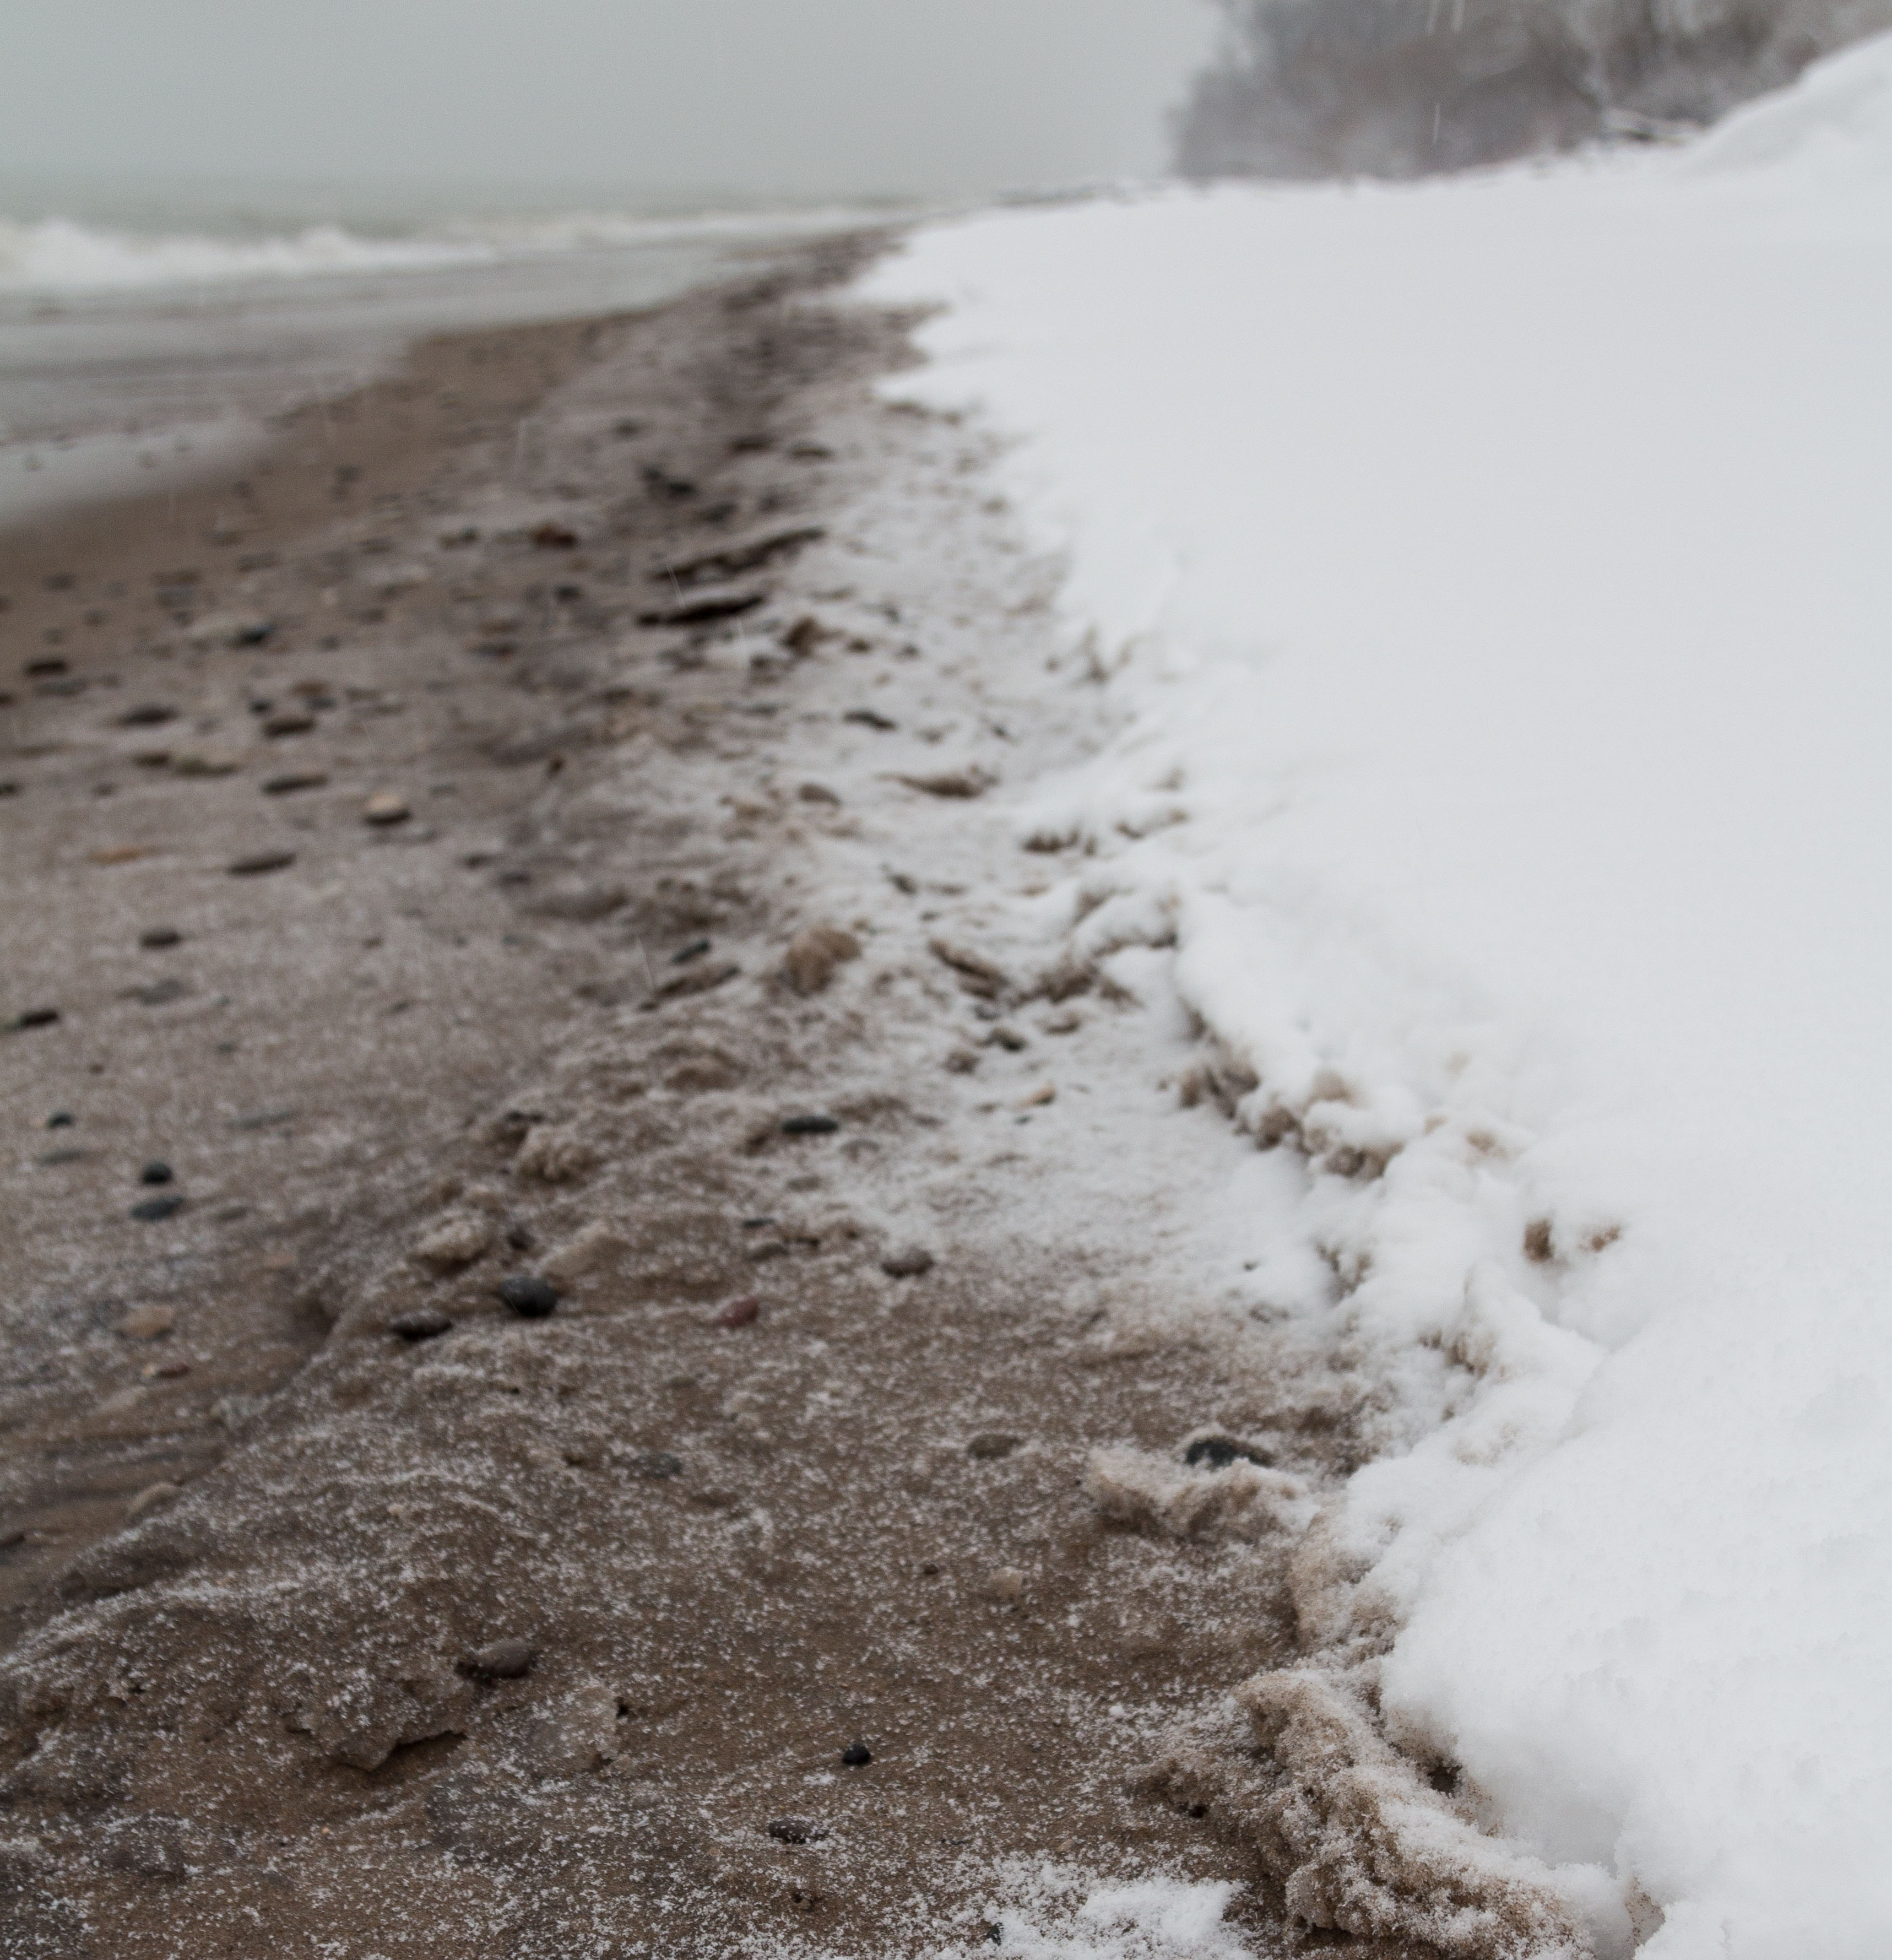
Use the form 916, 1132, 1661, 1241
0, 208, 886, 294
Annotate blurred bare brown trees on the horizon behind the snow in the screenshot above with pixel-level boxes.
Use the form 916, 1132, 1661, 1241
1174, 0, 1892, 178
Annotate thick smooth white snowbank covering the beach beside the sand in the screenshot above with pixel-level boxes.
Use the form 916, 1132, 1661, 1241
865, 39, 1892, 1960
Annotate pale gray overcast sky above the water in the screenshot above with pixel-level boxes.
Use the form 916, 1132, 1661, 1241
0, 0, 1213, 196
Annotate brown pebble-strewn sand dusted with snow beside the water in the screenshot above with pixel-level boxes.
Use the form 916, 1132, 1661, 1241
0, 243, 1427, 1960
